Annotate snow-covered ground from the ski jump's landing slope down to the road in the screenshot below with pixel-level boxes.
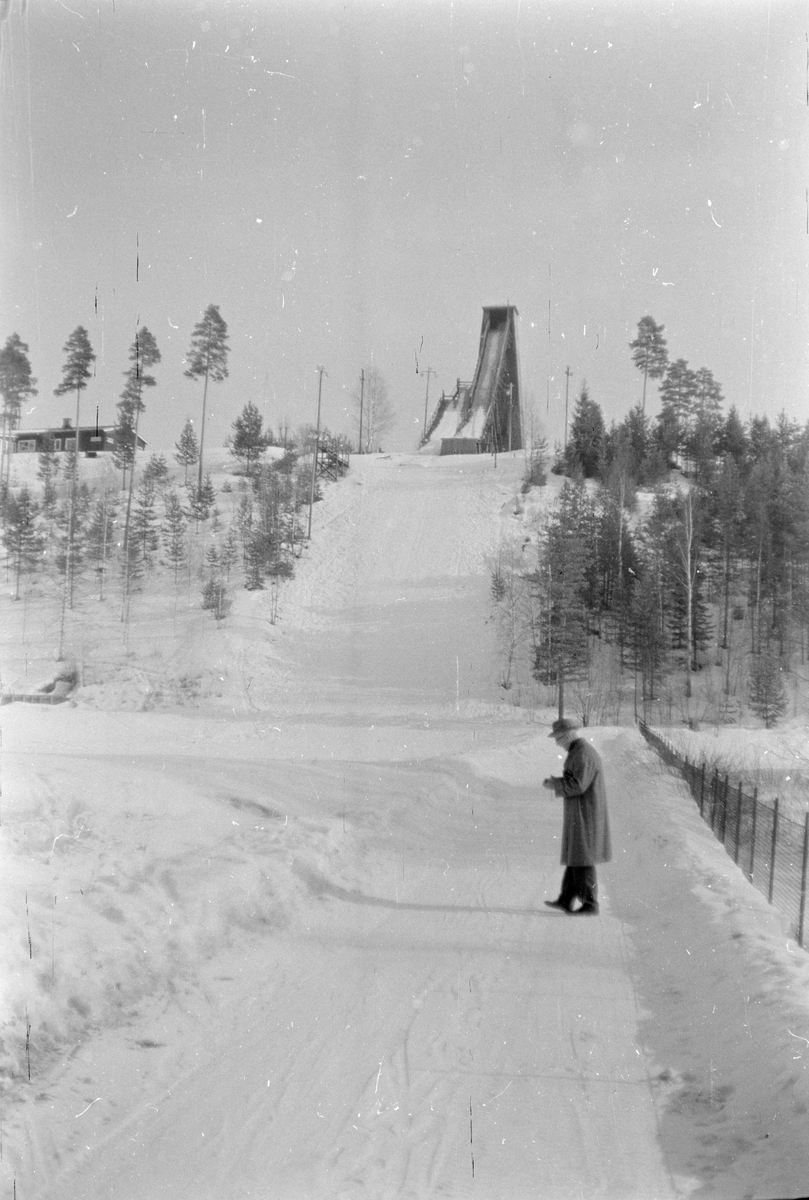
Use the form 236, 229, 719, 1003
0, 455, 809, 1200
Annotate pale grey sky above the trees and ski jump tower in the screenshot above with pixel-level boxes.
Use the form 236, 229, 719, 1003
0, 0, 809, 452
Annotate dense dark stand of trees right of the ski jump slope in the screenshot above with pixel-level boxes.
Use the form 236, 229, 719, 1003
492, 318, 809, 726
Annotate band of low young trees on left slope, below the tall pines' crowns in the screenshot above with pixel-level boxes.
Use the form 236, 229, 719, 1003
0, 436, 320, 620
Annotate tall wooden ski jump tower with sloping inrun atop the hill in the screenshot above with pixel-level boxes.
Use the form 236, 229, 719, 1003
421, 305, 522, 454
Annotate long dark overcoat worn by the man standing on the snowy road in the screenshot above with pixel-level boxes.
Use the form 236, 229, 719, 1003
557, 738, 612, 866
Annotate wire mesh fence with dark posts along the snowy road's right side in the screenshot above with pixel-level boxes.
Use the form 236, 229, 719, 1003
637, 721, 809, 947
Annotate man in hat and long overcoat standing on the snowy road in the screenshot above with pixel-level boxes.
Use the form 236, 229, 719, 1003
543, 716, 612, 917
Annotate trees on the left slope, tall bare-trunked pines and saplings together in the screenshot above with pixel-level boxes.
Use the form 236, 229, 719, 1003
0, 314, 343, 653
